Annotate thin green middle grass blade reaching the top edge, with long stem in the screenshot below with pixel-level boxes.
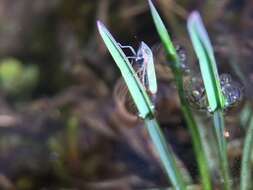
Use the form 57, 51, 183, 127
149, 0, 212, 190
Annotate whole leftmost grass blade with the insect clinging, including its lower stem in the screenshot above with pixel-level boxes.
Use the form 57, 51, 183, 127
97, 21, 185, 190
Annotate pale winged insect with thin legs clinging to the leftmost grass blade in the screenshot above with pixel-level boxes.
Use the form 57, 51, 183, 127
118, 41, 157, 94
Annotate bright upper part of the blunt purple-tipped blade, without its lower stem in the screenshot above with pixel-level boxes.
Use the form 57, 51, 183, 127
187, 11, 225, 112
